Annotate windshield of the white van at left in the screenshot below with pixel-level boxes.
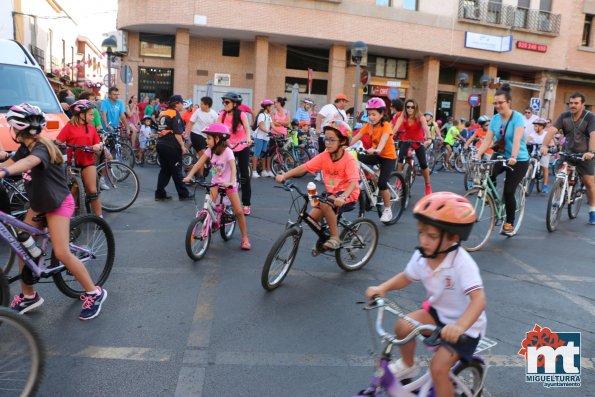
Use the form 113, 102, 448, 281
0, 64, 62, 113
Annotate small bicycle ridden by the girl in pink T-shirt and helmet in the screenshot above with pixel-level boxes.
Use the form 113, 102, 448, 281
185, 181, 236, 261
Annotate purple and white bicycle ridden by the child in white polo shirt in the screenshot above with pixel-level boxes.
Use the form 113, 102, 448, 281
356, 297, 497, 397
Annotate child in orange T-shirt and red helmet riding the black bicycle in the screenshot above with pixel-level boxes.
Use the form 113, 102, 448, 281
275, 120, 359, 250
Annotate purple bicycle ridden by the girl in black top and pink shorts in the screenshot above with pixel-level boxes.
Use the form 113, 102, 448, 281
0, 211, 115, 306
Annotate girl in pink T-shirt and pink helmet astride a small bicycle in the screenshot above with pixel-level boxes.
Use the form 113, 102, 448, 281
182, 123, 252, 250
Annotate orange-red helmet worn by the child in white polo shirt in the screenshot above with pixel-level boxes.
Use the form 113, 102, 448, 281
413, 192, 477, 240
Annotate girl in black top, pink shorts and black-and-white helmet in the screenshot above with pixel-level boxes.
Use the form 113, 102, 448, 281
0, 103, 107, 320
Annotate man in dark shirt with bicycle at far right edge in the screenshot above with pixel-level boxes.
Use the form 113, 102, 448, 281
541, 92, 595, 225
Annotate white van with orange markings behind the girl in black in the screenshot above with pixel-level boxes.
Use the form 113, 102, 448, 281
0, 39, 68, 150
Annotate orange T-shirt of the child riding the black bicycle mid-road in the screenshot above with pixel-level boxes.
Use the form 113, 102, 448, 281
304, 152, 359, 203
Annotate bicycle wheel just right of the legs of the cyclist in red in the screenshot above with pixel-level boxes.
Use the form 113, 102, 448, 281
97, 161, 140, 212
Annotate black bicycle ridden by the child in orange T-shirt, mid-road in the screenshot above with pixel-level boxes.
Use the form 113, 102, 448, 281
260, 182, 378, 291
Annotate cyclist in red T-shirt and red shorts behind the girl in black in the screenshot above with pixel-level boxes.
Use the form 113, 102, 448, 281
56, 99, 103, 216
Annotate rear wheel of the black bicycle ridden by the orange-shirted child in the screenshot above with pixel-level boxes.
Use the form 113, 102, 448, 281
335, 219, 378, 272
